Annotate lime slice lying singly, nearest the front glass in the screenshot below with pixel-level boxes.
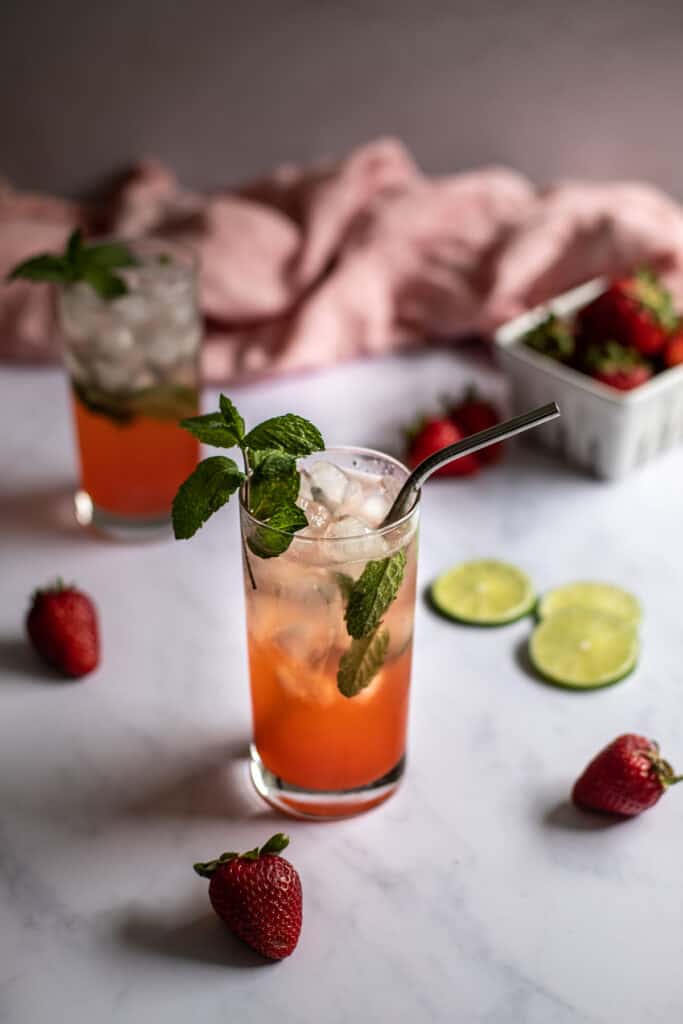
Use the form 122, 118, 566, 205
430, 558, 536, 626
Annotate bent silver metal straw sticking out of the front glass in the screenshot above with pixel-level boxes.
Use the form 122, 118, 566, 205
382, 401, 560, 526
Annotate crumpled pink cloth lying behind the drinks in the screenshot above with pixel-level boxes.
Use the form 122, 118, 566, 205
0, 139, 683, 382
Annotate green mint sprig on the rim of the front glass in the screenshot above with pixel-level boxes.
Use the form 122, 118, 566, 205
173, 394, 325, 558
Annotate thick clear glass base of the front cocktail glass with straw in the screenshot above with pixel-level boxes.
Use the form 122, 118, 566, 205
249, 743, 405, 821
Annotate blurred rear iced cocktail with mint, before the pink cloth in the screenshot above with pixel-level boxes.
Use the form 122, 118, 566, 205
12, 231, 201, 536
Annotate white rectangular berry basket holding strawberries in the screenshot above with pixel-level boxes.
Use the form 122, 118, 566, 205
494, 279, 683, 479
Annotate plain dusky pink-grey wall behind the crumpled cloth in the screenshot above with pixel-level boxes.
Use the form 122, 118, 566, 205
0, 0, 683, 196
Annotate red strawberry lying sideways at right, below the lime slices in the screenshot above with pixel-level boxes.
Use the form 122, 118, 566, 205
571, 733, 683, 817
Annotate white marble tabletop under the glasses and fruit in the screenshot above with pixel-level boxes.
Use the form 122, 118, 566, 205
0, 352, 683, 1024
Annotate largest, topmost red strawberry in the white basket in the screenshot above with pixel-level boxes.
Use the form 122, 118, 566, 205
578, 270, 678, 355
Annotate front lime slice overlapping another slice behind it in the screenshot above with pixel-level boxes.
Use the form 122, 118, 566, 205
528, 608, 638, 690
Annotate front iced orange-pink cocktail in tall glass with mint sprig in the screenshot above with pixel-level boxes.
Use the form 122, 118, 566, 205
173, 395, 418, 818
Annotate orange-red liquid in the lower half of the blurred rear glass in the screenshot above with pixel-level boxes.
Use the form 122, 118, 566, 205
73, 395, 199, 519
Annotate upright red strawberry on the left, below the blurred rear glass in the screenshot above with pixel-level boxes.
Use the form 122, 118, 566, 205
26, 580, 99, 677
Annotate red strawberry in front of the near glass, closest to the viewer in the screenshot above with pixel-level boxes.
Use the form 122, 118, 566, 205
195, 833, 302, 959
